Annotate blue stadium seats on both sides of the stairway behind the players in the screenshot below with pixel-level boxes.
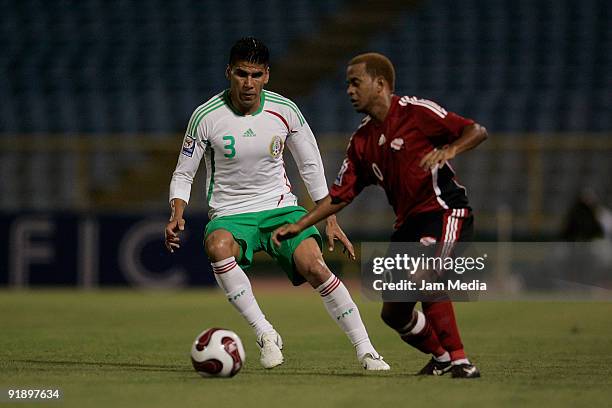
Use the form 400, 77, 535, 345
0, 0, 612, 133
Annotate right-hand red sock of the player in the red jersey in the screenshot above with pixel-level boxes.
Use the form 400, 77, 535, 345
422, 301, 466, 361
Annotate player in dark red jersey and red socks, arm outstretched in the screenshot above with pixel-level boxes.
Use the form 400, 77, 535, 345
273, 53, 487, 378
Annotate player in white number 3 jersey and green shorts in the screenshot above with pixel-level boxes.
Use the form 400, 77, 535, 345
165, 37, 389, 370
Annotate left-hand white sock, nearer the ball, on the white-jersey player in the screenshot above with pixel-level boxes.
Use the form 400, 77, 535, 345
212, 256, 274, 338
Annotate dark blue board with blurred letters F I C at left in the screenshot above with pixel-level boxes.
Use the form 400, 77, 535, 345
0, 212, 214, 288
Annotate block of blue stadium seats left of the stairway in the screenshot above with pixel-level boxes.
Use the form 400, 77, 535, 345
0, 0, 341, 133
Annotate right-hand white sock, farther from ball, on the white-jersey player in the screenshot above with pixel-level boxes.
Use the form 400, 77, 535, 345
317, 274, 378, 359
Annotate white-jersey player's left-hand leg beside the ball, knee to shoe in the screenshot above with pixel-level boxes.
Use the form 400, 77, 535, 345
205, 229, 283, 368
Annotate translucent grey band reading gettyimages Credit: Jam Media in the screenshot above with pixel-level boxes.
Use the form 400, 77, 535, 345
361, 242, 612, 302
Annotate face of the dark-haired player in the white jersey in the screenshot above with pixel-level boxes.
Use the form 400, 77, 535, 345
225, 61, 270, 114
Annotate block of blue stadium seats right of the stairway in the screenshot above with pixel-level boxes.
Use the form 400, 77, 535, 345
303, 0, 612, 132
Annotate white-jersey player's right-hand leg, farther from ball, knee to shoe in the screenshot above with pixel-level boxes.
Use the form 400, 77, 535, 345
293, 237, 389, 370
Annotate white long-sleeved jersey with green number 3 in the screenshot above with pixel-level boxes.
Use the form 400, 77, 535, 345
170, 90, 328, 219
